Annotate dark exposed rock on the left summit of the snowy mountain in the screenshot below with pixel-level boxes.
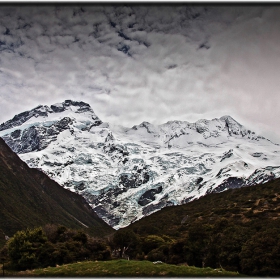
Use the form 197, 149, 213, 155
0, 100, 102, 154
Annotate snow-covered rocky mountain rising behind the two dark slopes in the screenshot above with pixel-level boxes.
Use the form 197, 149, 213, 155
0, 100, 280, 229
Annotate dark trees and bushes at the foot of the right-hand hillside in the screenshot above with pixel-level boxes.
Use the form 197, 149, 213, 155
114, 218, 280, 276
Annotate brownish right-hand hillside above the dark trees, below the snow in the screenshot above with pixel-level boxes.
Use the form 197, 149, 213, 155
120, 178, 280, 238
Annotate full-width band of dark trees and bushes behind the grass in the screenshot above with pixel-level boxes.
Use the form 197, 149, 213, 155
1, 218, 280, 276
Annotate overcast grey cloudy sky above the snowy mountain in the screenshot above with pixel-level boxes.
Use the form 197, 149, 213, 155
0, 3, 280, 143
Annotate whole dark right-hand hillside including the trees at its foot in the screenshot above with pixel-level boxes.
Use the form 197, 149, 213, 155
114, 179, 280, 276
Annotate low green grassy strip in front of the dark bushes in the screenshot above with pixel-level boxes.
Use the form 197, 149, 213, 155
10, 260, 244, 277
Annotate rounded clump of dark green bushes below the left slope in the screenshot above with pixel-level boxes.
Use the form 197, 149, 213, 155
1, 225, 111, 270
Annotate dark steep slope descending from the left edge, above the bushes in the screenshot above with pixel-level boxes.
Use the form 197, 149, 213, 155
0, 138, 113, 246
